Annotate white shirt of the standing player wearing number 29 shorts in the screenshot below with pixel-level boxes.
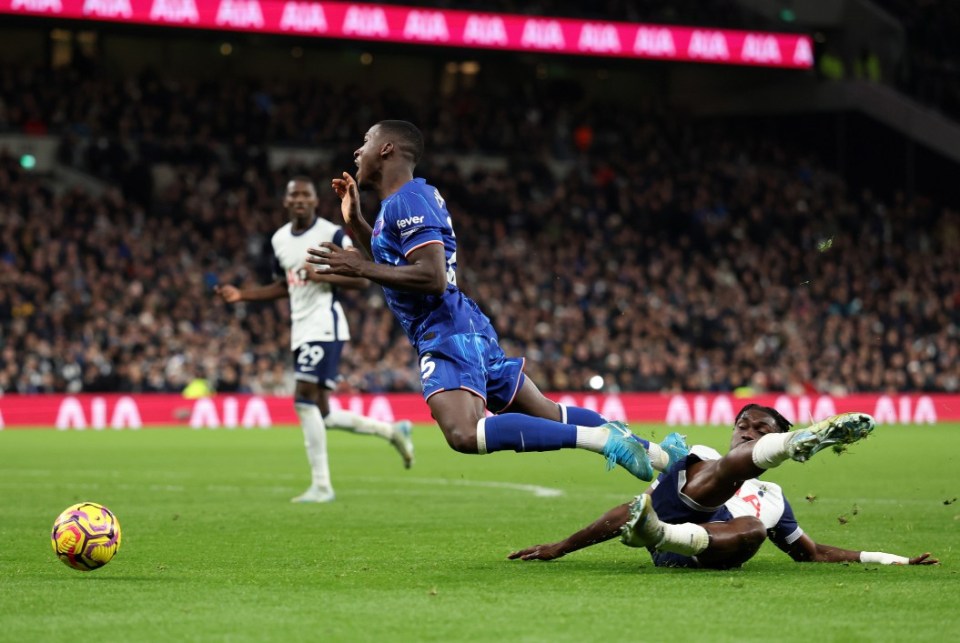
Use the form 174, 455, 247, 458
271, 217, 353, 351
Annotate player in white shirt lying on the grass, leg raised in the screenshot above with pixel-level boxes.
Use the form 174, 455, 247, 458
509, 404, 939, 569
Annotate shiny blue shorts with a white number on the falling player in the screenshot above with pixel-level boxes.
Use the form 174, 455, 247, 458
420, 334, 524, 413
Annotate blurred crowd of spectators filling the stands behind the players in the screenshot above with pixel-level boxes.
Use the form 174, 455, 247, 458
0, 69, 960, 394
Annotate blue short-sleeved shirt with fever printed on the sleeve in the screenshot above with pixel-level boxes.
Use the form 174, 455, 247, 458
370, 179, 496, 353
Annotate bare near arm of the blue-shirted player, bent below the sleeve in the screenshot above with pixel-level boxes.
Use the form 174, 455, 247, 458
307, 241, 447, 295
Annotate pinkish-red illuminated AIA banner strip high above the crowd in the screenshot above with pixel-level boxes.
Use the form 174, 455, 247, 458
0, 0, 813, 69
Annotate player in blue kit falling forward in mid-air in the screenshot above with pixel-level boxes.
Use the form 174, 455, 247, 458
308, 120, 686, 480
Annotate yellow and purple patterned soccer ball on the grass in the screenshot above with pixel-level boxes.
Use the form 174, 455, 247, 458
51, 502, 120, 572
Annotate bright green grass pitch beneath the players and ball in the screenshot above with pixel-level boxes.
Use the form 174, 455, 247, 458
0, 425, 960, 643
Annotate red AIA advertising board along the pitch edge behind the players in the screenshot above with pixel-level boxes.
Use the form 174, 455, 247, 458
0, 393, 948, 430
